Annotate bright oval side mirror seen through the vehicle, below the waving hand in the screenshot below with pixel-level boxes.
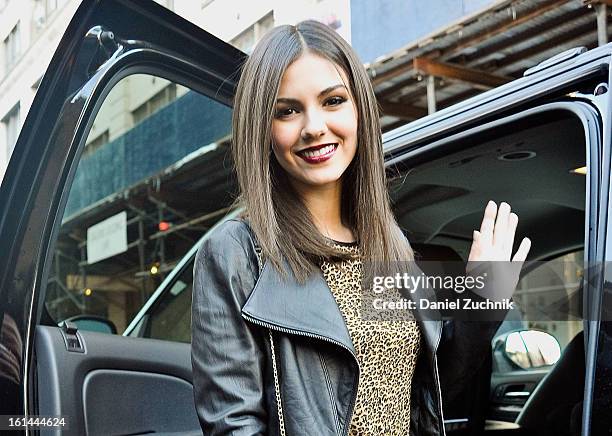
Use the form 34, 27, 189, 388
504, 330, 561, 369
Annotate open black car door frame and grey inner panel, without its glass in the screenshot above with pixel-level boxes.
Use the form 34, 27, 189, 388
0, 0, 244, 435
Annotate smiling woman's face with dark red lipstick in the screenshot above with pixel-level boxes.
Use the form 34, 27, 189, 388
272, 53, 357, 192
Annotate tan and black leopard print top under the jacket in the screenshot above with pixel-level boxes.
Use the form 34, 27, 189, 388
320, 242, 421, 436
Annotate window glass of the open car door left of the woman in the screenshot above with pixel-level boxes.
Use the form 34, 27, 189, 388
45, 74, 233, 334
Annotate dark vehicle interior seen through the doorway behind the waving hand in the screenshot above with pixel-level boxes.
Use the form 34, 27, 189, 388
391, 106, 587, 435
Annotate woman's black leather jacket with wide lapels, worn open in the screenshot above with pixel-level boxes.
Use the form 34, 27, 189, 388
192, 219, 499, 436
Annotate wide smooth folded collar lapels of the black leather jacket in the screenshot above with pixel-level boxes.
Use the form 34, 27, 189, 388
242, 255, 442, 359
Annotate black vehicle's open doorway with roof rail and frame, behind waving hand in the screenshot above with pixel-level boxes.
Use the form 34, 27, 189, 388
383, 45, 612, 436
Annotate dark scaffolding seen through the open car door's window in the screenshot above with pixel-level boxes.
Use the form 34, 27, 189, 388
46, 139, 235, 330
